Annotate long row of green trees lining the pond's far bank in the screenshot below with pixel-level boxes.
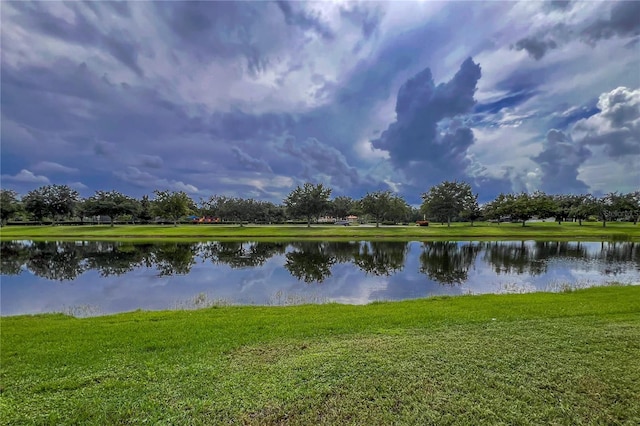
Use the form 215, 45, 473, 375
0, 181, 640, 226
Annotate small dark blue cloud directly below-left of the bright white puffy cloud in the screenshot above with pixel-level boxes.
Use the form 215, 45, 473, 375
533, 129, 591, 194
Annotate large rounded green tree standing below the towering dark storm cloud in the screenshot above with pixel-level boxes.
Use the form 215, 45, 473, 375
422, 181, 474, 226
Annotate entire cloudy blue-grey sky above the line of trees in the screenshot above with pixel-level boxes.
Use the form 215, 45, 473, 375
0, 1, 640, 205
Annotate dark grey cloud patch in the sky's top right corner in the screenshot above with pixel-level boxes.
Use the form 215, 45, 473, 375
581, 1, 640, 43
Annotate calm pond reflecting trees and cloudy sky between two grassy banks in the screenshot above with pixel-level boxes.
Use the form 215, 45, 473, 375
0, 241, 640, 316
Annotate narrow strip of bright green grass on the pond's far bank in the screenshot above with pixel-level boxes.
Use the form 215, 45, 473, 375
0, 222, 640, 241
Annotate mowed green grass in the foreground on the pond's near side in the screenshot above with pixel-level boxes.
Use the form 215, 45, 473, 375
0, 286, 640, 425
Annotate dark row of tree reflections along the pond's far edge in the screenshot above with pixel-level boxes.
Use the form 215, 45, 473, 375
0, 241, 640, 285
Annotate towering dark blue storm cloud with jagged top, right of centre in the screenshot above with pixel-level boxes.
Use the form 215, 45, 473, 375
372, 58, 480, 175
